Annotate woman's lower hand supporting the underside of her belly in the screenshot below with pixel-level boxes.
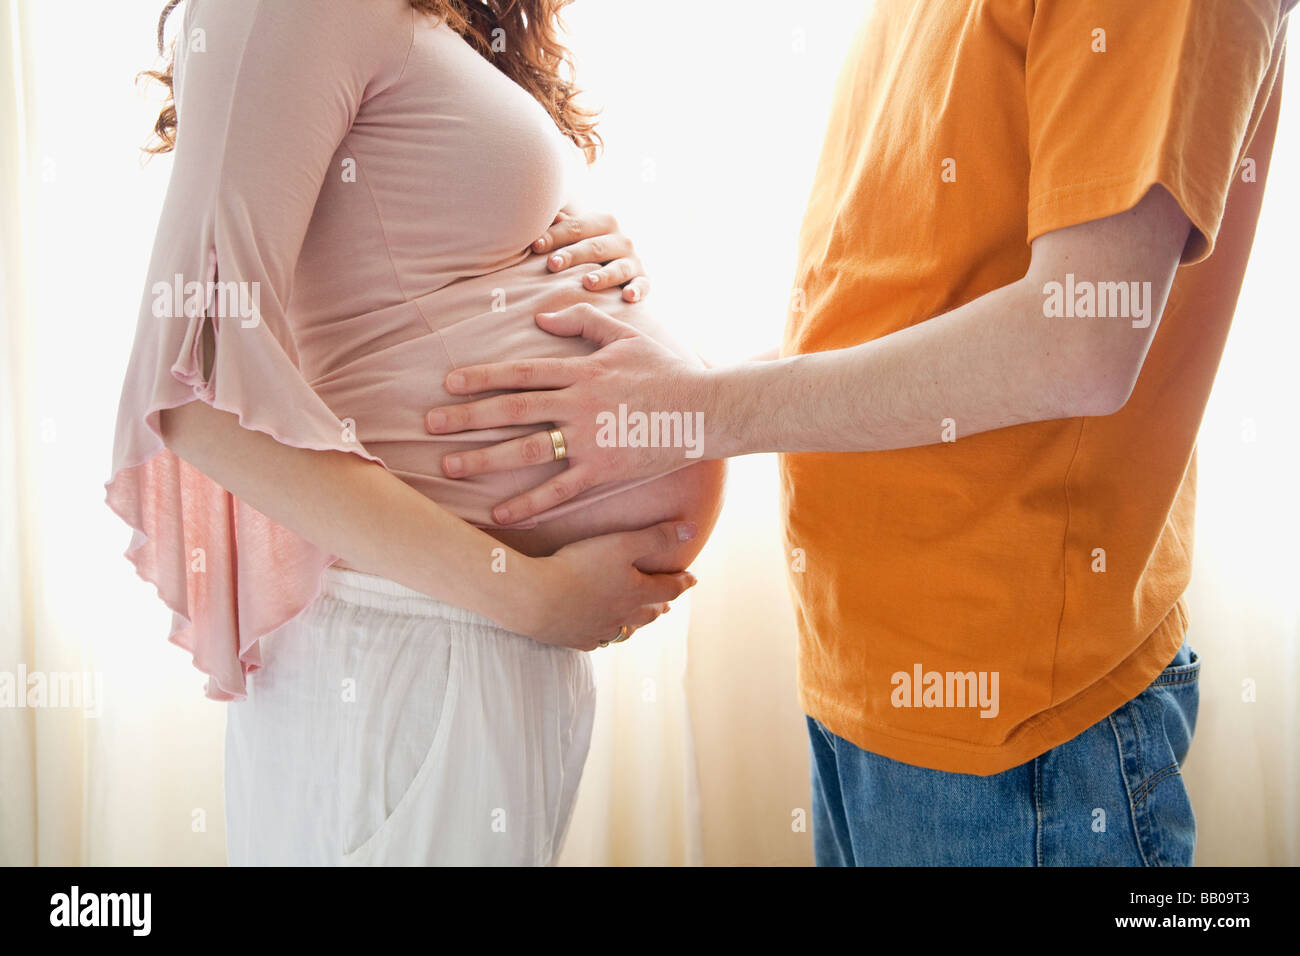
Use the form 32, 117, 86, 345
512, 522, 697, 650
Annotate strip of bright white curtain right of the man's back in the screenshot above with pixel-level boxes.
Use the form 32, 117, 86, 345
1180, 67, 1300, 866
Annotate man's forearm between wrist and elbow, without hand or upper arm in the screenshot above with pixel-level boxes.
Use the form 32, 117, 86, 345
701, 278, 1139, 458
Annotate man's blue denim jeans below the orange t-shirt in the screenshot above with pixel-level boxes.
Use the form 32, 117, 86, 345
807, 643, 1201, 866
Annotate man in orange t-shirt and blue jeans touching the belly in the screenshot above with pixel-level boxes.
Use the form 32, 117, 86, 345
429, 0, 1295, 865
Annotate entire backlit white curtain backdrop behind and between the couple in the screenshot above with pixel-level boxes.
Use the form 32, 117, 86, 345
0, 0, 1300, 865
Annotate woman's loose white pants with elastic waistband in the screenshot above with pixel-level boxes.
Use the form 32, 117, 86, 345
226, 568, 595, 866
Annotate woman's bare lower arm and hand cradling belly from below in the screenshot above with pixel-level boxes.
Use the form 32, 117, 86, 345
160, 402, 694, 650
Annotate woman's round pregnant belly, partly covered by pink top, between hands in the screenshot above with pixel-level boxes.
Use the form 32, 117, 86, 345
312, 256, 724, 571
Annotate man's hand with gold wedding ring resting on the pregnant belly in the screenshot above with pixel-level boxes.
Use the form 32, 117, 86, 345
425, 304, 720, 524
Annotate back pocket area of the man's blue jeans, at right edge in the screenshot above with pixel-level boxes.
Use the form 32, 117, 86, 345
1109, 644, 1201, 866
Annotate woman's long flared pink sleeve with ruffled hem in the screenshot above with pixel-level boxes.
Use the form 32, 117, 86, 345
107, 0, 412, 700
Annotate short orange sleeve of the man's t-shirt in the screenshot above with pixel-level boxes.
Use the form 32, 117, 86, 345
1026, 0, 1283, 263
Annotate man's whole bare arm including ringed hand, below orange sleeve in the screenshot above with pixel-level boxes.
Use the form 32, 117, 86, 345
428, 186, 1191, 523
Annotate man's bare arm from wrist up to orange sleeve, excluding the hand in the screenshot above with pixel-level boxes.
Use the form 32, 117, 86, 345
705, 186, 1190, 455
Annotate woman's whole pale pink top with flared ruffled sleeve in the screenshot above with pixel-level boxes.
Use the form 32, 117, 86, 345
107, 0, 686, 700
